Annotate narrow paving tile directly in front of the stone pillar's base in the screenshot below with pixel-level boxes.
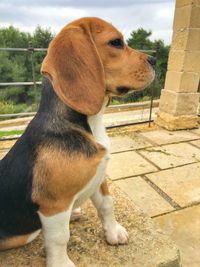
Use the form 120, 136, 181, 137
140, 130, 200, 145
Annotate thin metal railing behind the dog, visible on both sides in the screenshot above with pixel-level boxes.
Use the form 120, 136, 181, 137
0, 42, 159, 139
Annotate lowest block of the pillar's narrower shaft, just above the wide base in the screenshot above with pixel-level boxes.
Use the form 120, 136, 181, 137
165, 71, 199, 93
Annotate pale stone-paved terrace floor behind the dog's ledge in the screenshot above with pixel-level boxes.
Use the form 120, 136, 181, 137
0, 129, 200, 267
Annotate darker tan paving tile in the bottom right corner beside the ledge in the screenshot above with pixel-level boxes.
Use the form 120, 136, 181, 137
153, 205, 200, 267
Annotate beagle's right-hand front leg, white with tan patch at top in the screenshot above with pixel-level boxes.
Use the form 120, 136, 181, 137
91, 181, 128, 245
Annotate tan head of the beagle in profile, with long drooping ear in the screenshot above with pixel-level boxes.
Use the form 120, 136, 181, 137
41, 18, 154, 115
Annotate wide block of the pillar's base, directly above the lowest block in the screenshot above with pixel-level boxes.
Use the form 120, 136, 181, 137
159, 90, 199, 116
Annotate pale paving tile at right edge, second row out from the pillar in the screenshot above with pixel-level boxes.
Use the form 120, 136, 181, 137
140, 143, 200, 169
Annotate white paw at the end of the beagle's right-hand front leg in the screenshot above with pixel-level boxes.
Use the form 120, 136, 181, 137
104, 223, 128, 245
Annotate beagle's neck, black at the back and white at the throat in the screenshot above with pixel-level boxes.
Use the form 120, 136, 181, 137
35, 78, 109, 149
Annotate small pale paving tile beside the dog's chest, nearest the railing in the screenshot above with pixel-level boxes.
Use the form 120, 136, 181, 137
111, 136, 152, 153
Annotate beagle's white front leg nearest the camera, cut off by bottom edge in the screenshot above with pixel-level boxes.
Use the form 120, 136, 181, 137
39, 208, 75, 267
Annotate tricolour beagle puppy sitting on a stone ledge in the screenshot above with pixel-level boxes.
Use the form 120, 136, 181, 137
0, 18, 155, 267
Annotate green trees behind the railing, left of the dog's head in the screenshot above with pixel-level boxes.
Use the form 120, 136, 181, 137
0, 26, 54, 114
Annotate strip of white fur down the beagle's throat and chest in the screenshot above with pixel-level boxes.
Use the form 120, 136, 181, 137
74, 99, 110, 207
